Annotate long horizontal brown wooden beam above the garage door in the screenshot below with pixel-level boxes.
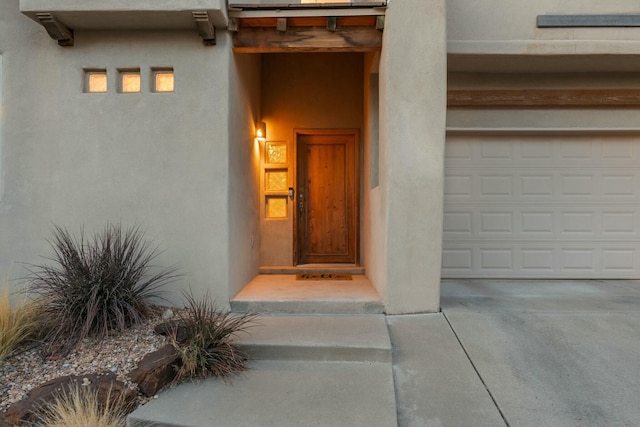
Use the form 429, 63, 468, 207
447, 89, 640, 108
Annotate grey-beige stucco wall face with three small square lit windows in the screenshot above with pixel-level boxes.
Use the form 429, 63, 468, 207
0, 0, 238, 308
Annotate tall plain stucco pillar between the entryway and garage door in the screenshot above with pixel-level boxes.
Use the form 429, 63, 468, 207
380, 0, 447, 313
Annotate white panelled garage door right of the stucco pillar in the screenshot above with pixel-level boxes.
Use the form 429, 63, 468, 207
443, 135, 640, 278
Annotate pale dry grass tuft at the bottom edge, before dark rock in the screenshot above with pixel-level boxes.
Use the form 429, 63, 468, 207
39, 385, 128, 427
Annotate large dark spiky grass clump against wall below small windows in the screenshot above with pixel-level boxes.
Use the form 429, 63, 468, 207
27, 223, 179, 355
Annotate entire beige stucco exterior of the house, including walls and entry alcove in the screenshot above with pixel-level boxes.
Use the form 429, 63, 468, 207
0, 0, 640, 313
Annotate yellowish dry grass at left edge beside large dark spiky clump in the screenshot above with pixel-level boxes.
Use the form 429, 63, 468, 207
0, 286, 38, 360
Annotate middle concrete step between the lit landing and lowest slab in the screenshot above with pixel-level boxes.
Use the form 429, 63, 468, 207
238, 315, 392, 363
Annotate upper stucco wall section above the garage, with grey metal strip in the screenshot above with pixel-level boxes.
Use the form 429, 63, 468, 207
447, 0, 640, 55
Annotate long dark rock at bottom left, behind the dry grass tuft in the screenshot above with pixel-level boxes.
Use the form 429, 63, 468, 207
0, 372, 137, 427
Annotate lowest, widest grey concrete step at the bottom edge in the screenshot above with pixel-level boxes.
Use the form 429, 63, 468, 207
127, 360, 398, 427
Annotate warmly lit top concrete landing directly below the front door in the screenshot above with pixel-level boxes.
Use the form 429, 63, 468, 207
230, 274, 384, 314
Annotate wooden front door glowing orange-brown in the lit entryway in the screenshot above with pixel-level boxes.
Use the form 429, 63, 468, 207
295, 131, 358, 264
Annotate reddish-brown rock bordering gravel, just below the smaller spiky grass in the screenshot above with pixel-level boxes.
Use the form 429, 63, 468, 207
129, 344, 182, 397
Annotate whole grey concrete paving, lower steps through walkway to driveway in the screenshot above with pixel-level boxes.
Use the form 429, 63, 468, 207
129, 280, 640, 427
